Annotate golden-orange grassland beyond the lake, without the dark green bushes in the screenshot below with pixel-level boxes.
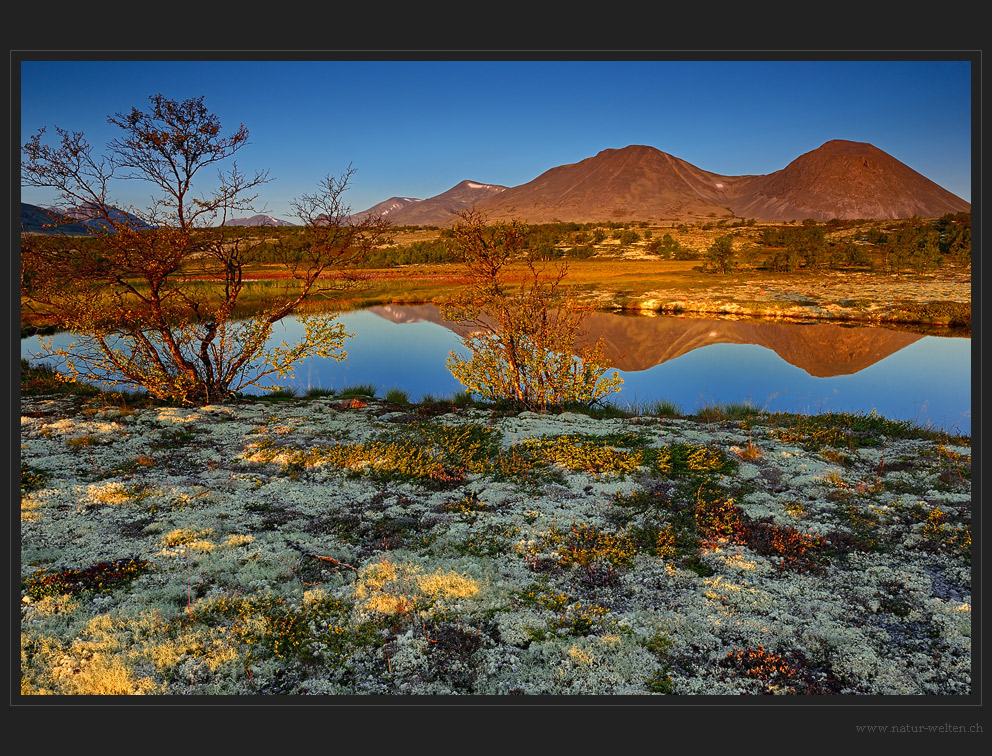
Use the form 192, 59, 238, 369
22, 221, 972, 329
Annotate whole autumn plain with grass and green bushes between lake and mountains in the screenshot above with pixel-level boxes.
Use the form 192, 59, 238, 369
22, 213, 971, 332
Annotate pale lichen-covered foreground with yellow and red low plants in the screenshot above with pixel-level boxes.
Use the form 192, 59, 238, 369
21, 396, 972, 697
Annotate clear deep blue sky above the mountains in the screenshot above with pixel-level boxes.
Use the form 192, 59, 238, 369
15, 54, 973, 222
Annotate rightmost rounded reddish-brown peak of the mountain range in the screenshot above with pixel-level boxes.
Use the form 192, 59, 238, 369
729, 139, 971, 221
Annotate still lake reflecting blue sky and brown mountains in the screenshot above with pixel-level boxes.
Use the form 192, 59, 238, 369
21, 305, 971, 435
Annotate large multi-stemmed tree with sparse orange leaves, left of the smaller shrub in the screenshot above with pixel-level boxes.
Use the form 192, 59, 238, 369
21, 95, 382, 404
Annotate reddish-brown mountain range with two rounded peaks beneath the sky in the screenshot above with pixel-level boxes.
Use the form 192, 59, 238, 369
364, 139, 971, 225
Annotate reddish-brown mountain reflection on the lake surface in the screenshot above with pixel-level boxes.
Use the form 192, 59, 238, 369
369, 304, 922, 378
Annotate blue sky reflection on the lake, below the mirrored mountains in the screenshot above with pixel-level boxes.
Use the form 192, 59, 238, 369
21, 308, 971, 435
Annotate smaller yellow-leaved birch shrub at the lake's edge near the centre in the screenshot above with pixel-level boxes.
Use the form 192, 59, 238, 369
442, 212, 623, 411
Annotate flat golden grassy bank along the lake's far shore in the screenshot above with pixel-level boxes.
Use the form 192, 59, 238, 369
21, 256, 972, 338
